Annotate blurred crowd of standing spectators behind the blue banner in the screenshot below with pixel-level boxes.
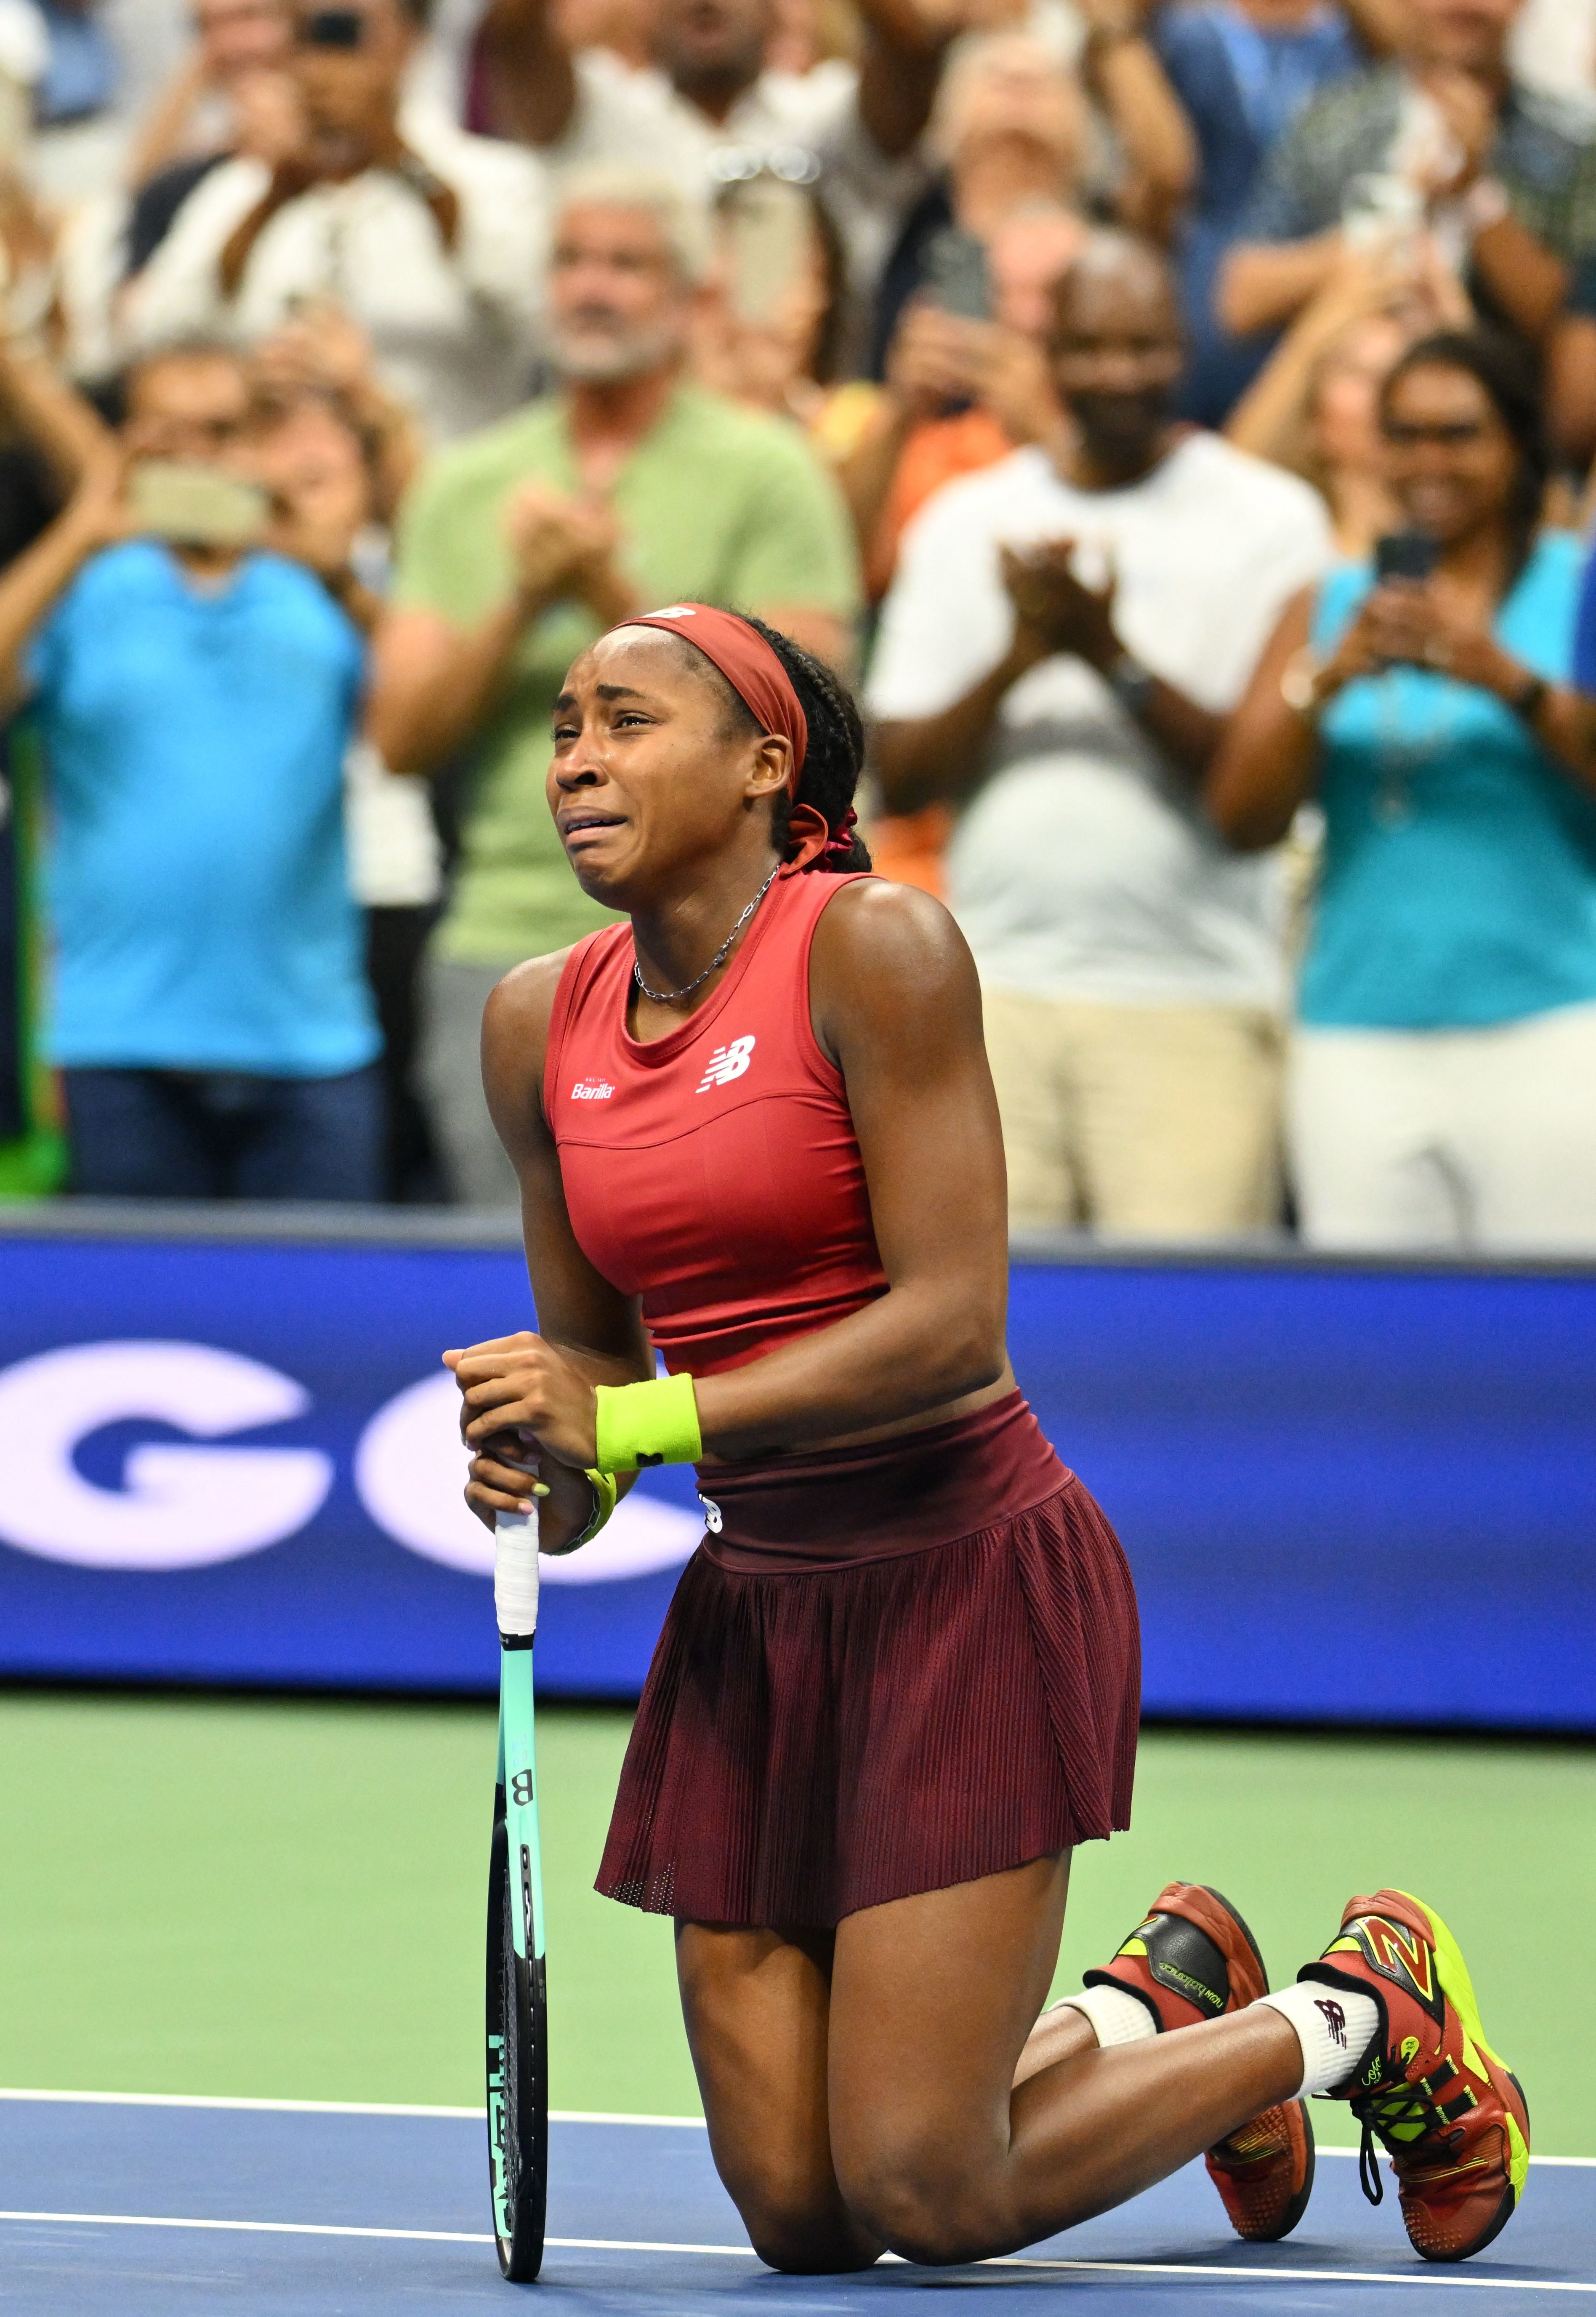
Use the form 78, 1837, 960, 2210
0, 0, 1596, 1256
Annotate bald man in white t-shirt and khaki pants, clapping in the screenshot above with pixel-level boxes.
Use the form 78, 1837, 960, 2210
869, 234, 1330, 1237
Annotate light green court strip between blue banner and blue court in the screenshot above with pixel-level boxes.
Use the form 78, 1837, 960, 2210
0, 1694, 1596, 2155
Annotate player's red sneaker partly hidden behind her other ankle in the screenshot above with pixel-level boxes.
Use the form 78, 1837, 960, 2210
1086, 1884, 1314, 2245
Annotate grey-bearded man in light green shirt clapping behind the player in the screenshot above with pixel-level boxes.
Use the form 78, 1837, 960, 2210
373, 169, 859, 1205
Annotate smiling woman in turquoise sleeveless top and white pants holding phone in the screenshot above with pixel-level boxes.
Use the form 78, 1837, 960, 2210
1207, 331, 1596, 1254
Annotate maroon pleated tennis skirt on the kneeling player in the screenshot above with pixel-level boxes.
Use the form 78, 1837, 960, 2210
598, 1393, 1142, 1928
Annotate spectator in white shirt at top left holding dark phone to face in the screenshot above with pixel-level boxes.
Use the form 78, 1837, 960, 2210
128, 0, 547, 440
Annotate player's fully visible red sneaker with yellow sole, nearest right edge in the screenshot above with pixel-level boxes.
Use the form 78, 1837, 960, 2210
1297, 1891, 1529, 2261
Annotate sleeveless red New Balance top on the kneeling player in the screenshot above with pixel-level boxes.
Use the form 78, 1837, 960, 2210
544, 869, 887, 1376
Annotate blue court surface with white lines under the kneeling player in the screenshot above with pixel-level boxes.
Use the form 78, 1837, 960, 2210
0, 2092, 1596, 2317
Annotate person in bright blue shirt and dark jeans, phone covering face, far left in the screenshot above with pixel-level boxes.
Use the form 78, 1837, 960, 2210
0, 348, 382, 1200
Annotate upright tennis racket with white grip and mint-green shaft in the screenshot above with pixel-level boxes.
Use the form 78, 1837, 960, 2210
487, 1513, 549, 2285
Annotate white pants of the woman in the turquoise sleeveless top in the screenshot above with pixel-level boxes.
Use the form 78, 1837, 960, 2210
1286, 1006, 1596, 1256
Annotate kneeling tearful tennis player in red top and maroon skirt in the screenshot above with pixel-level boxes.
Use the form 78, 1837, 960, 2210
447, 605, 1529, 2271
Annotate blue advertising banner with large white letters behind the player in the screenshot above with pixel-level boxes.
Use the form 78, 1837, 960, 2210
0, 1230, 1596, 1731
